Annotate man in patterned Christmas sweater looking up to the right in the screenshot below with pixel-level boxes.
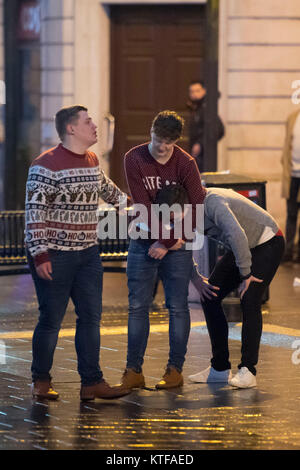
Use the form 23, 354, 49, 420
25, 105, 131, 400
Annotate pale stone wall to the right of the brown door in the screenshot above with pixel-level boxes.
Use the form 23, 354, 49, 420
219, 0, 300, 227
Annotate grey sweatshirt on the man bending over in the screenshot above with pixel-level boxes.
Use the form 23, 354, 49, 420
204, 188, 279, 277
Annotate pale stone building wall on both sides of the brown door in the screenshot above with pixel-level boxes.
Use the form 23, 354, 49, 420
0, 0, 300, 227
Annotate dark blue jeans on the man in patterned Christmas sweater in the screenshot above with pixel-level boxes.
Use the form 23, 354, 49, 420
28, 246, 103, 385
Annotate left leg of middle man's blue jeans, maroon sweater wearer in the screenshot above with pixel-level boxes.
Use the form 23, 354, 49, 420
127, 240, 160, 373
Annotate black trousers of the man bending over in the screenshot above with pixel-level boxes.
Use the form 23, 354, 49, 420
202, 236, 285, 375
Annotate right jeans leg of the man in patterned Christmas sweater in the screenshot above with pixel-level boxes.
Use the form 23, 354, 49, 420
71, 246, 103, 385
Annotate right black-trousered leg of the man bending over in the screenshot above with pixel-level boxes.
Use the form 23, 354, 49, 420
239, 237, 284, 375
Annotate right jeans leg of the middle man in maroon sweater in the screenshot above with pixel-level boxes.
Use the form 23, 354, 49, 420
159, 250, 192, 372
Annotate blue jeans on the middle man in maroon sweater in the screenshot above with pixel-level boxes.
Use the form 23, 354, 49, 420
127, 240, 192, 372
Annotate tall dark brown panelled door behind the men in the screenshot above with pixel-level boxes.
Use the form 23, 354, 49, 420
110, 5, 205, 190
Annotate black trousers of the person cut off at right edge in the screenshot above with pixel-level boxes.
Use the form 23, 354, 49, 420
286, 177, 300, 255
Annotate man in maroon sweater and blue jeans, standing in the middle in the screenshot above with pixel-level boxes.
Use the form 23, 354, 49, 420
121, 111, 205, 389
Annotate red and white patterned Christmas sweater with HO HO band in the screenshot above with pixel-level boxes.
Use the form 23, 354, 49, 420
25, 144, 127, 266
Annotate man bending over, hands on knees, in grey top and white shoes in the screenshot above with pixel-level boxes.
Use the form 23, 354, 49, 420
156, 184, 285, 388
